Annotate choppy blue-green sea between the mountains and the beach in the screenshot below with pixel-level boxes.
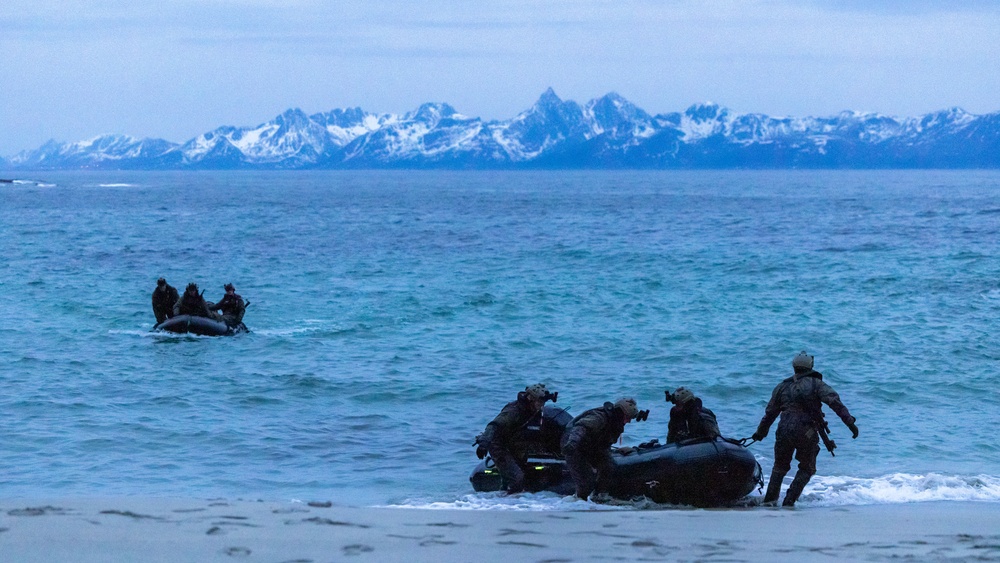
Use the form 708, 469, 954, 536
0, 171, 1000, 508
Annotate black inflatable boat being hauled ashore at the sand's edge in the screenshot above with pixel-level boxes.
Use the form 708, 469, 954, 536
469, 405, 763, 507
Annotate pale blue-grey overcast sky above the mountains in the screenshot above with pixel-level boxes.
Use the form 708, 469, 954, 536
0, 0, 1000, 156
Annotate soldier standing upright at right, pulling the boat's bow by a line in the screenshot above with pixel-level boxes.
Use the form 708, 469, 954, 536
752, 350, 858, 506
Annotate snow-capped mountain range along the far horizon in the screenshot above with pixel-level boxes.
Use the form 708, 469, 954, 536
0, 88, 1000, 170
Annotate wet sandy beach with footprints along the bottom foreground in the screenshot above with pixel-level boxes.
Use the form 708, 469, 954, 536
0, 497, 1000, 563
